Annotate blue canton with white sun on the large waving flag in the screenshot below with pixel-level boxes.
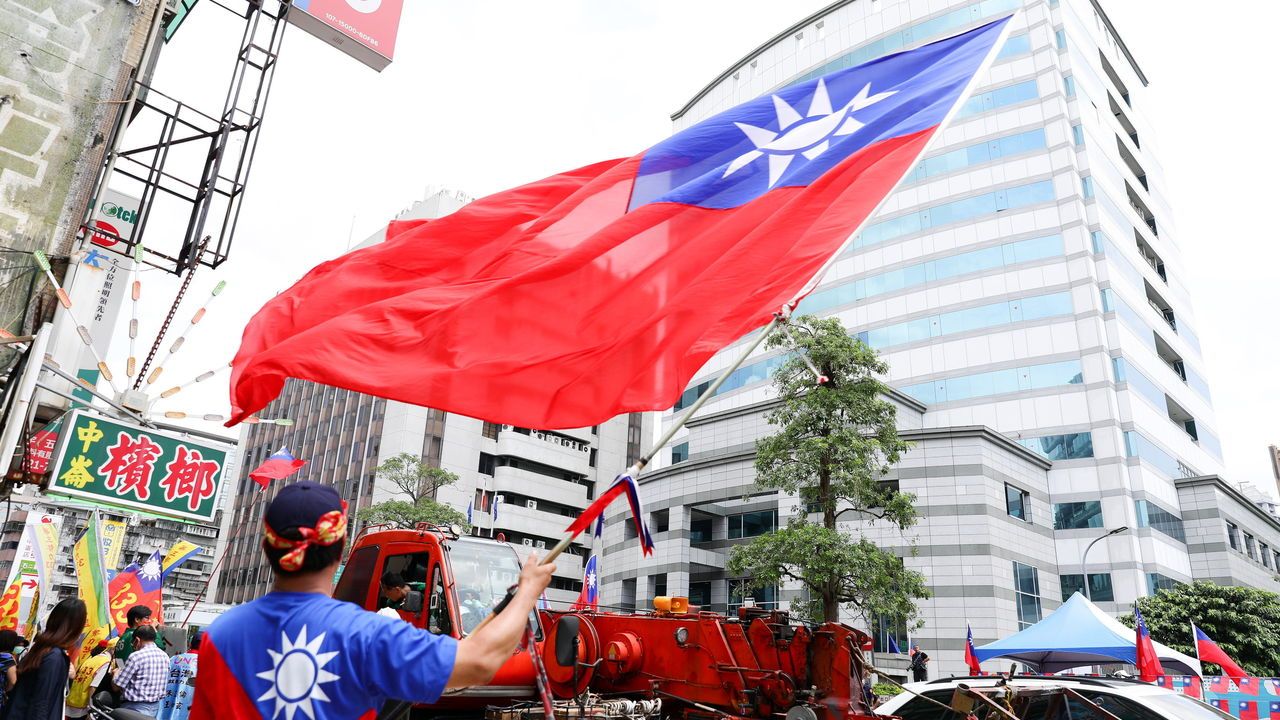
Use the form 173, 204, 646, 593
628, 18, 1007, 210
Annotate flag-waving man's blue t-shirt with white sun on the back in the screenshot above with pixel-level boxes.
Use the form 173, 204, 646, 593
191, 592, 458, 720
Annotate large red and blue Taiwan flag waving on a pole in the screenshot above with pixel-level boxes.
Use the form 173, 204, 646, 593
229, 18, 1010, 428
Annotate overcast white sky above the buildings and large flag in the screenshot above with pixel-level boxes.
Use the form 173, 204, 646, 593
111, 0, 1280, 493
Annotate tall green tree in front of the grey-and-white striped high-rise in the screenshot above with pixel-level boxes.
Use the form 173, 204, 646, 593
728, 316, 928, 623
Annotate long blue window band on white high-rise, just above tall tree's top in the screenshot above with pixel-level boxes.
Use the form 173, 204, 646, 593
795, 234, 1065, 315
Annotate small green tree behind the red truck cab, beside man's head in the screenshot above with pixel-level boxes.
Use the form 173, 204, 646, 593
356, 452, 468, 528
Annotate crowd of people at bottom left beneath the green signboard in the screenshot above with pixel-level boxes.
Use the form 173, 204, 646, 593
0, 598, 201, 720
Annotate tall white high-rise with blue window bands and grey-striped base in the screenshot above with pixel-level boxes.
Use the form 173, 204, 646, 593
603, 0, 1280, 671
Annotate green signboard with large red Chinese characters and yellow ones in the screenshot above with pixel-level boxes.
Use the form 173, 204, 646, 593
47, 410, 232, 521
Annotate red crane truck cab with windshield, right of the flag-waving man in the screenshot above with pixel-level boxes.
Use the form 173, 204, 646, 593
333, 527, 536, 710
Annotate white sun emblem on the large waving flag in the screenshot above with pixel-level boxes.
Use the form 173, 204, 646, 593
721, 79, 897, 187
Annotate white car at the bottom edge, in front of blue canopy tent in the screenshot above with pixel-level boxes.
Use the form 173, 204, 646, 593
876, 675, 1233, 720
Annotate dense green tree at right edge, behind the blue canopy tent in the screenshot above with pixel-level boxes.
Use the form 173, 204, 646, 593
1120, 582, 1280, 678
